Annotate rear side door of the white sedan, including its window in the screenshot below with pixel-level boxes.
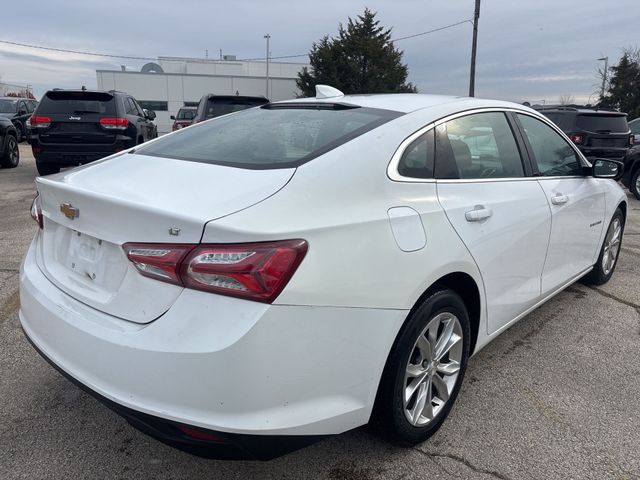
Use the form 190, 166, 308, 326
435, 111, 551, 334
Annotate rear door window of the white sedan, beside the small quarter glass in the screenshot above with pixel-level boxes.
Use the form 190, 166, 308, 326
435, 112, 524, 179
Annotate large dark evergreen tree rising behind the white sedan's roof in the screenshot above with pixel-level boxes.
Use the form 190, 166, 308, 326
296, 8, 416, 97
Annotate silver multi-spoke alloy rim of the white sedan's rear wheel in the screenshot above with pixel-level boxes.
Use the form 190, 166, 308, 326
403, 312, 463, 427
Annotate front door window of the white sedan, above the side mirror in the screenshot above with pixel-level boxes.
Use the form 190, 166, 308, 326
518, 114, 582, 177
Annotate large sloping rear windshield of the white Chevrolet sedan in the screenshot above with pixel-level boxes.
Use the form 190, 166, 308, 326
136, 104, 401, 169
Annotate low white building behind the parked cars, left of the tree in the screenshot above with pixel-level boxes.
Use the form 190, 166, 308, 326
96, 55, 308, 133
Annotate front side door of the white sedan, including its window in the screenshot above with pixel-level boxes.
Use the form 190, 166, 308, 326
516, 114, 605, 295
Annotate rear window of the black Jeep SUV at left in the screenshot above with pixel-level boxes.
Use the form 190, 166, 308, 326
38, 91, 116, 115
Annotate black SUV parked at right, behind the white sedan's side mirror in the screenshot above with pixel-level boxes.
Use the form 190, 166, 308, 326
533, 105, 633, 161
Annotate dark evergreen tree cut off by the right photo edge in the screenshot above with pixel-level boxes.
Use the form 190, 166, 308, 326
600, 50, 640, 119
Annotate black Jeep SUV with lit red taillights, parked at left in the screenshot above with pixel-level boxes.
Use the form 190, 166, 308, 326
30, 89, 158, 175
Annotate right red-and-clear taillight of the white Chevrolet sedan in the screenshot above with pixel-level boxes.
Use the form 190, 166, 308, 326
123, 240, 308, 303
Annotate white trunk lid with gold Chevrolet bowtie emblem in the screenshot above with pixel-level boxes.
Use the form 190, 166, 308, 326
36, 154, 295, 323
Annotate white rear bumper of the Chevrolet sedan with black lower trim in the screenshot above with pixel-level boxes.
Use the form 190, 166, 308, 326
20, 236, 407, 458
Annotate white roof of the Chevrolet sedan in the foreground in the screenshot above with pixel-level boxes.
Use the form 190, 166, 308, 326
275, 93, 535, 113
